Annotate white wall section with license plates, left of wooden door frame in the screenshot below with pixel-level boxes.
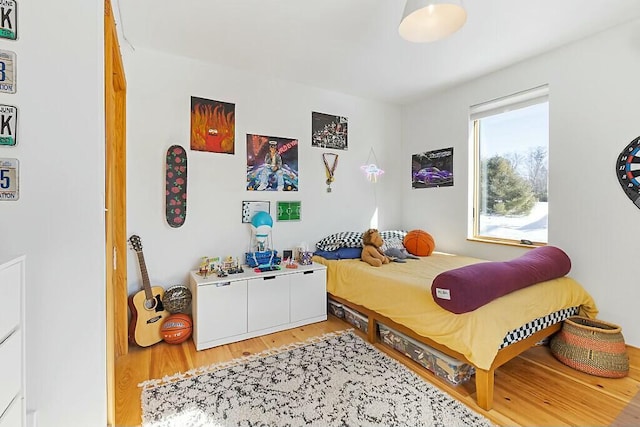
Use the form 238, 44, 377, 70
0, 0, 106, 427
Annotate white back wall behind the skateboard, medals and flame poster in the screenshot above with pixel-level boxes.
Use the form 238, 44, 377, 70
121, 47, 401, 292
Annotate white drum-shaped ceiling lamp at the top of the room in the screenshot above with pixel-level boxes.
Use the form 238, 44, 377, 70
398, 0, 467, 43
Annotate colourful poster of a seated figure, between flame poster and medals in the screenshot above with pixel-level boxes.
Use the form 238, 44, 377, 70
247, 134, 298, 191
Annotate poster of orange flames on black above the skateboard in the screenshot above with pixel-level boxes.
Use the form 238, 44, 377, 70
191, 96, 236, 154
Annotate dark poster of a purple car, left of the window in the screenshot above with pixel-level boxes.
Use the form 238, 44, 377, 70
411, 147, 453, 188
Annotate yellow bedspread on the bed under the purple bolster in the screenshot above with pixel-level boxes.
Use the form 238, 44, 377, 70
313, 252, 598, 369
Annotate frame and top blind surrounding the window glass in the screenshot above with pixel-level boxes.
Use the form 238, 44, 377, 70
467, 84, 549, 247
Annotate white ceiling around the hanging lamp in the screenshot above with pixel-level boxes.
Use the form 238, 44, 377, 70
114, 0, 640, 104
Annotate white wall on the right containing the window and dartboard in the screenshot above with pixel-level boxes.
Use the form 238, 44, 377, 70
402, 21, 640, 346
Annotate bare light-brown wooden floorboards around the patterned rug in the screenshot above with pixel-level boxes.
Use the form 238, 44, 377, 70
115, 316, 640, 426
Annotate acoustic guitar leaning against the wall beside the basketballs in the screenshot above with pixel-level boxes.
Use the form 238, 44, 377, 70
129, 234, 171, 347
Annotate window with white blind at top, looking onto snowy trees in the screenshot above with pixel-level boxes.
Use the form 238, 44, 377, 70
469, 86, 549, 245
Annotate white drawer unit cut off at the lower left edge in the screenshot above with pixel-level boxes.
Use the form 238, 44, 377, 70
0, 256, 26, 427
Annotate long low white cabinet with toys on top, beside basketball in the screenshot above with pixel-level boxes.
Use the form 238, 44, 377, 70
189, 264, 327, 352
